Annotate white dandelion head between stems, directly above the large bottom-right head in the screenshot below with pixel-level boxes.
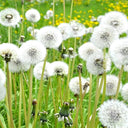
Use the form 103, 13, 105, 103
100, 75, 122, 96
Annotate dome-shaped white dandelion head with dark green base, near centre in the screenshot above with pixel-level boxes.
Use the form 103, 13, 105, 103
51, 61, 68, 76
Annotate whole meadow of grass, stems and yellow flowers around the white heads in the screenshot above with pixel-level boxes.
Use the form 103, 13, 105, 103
0, 0, 128, 128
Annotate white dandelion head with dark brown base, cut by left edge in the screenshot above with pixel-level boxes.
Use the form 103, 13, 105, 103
0, 43, 19, 62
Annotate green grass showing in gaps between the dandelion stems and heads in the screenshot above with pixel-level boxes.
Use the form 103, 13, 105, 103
0, 0, 128, 128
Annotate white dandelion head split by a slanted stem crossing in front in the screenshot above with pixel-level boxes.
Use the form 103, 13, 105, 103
33, 62, 53, 80
